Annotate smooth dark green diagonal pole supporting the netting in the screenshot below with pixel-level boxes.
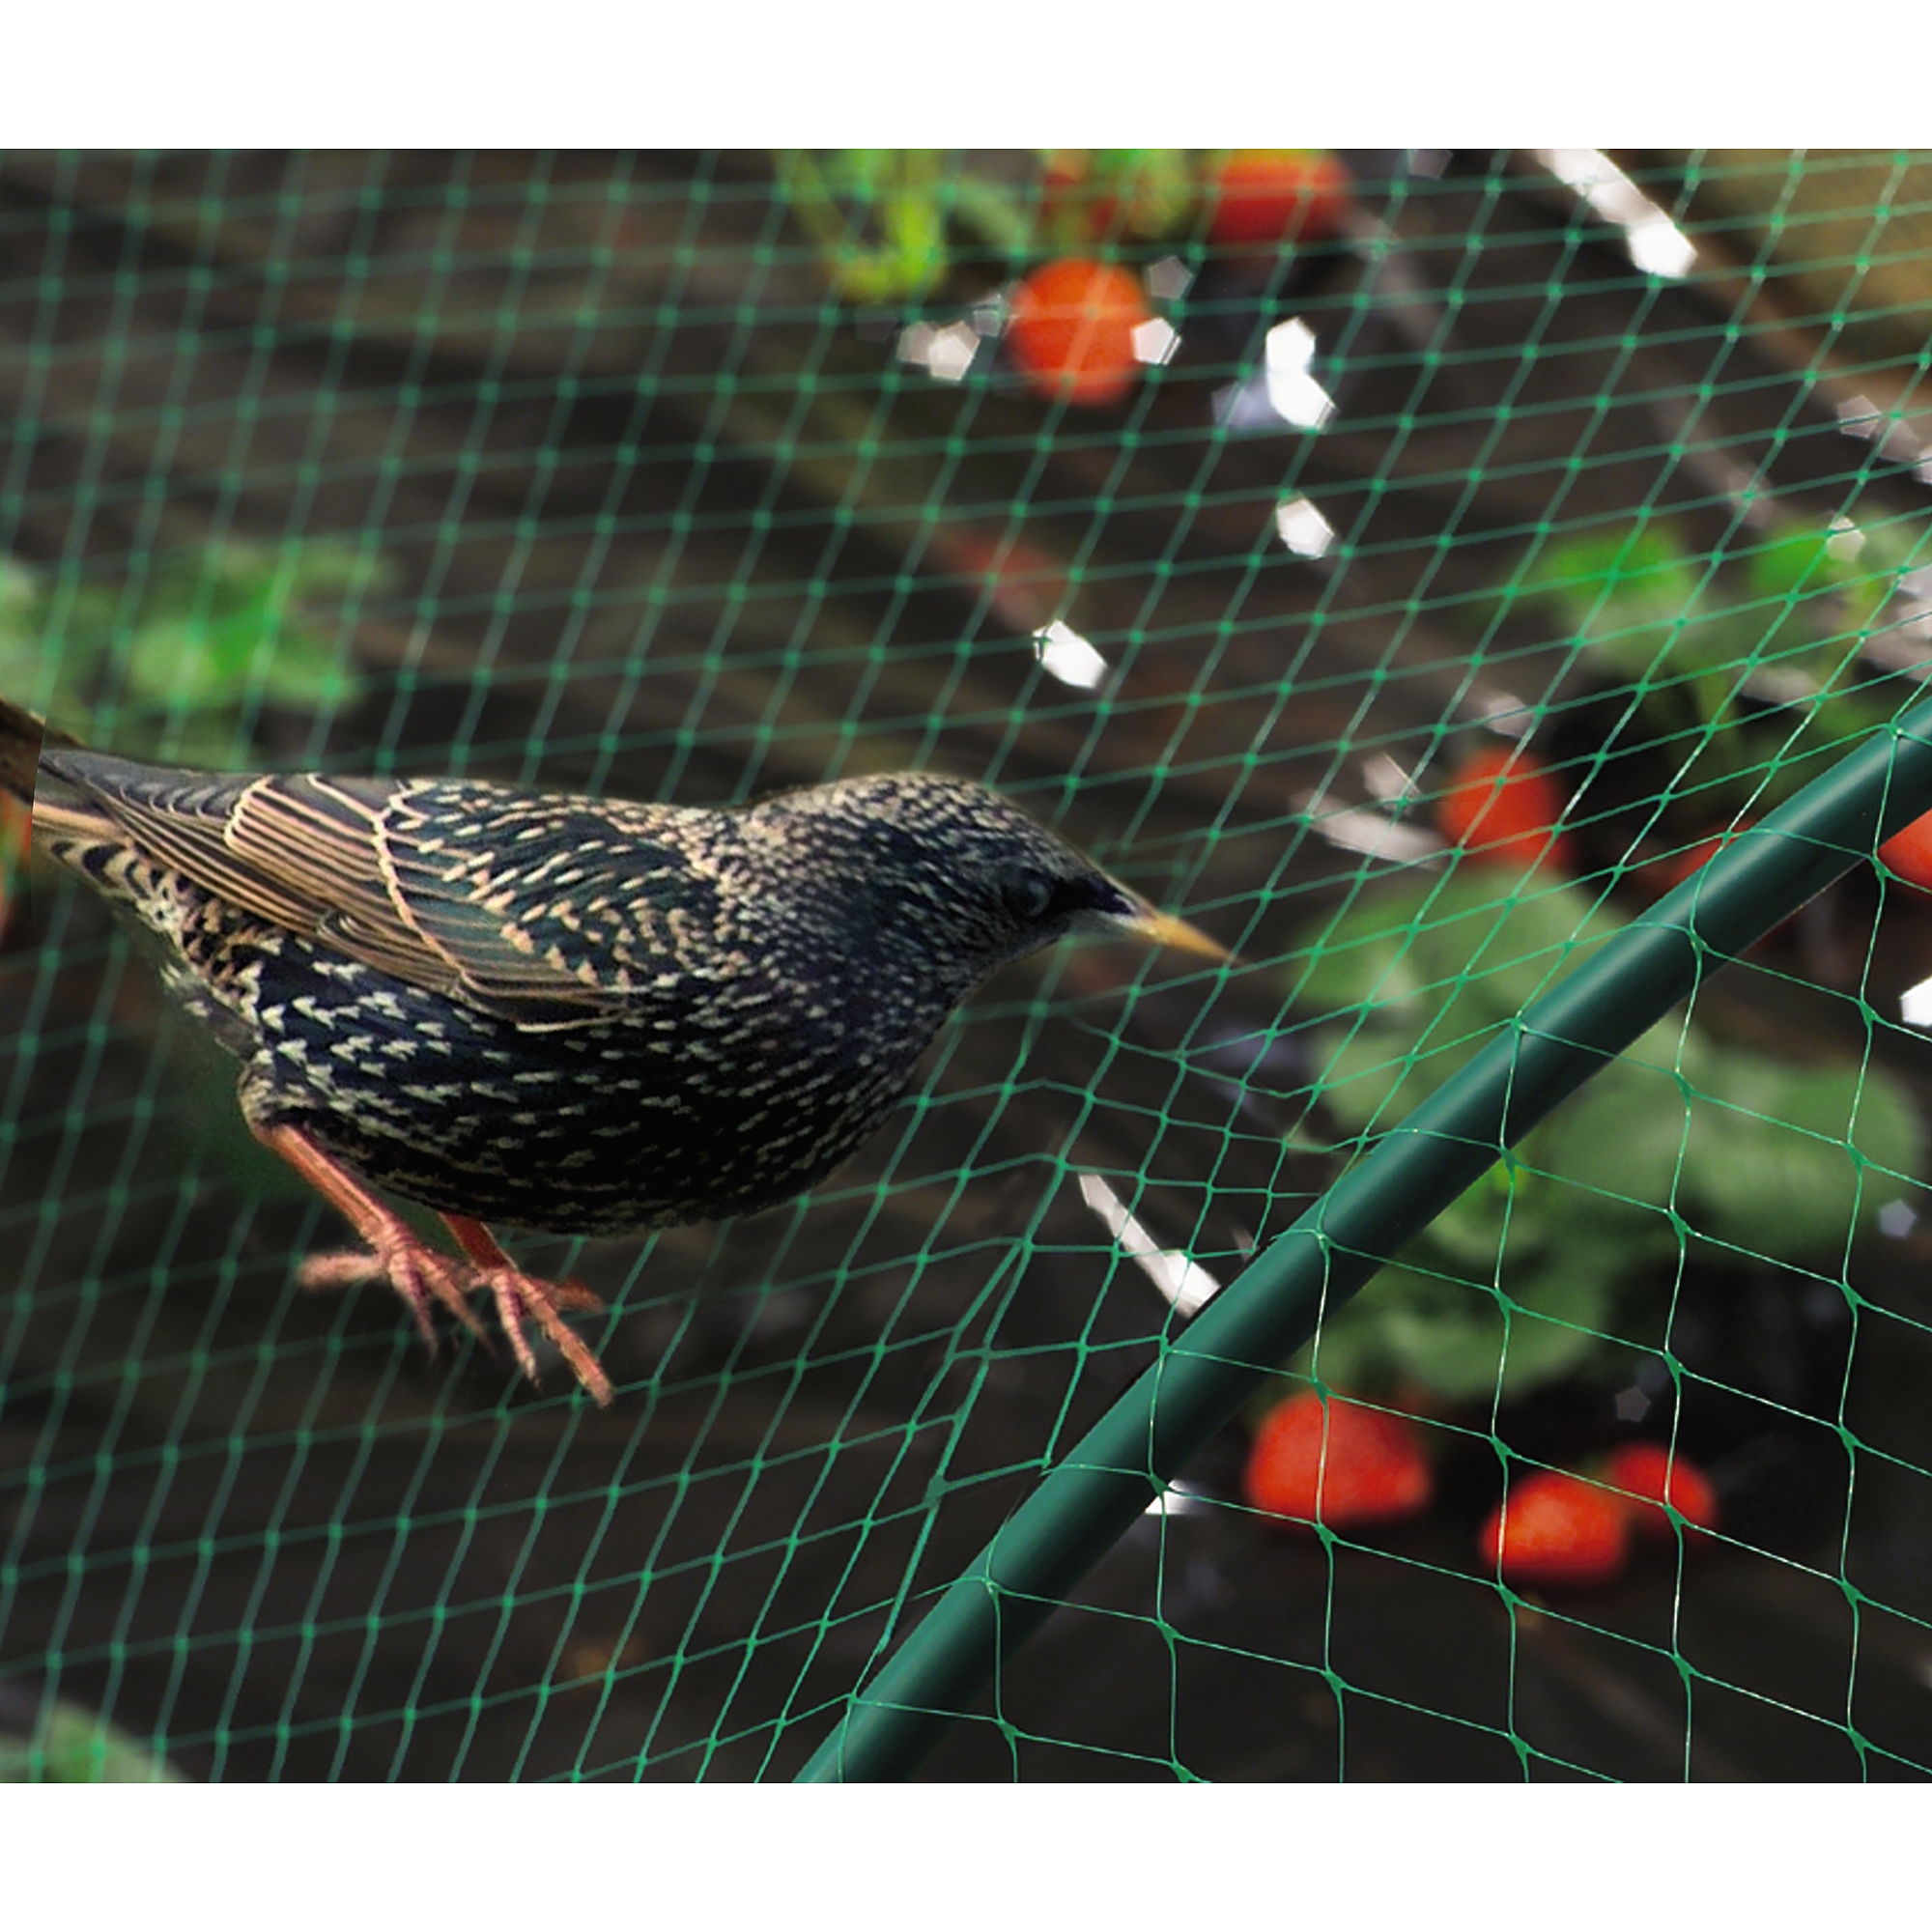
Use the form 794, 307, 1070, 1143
800, 701, 1932, 1781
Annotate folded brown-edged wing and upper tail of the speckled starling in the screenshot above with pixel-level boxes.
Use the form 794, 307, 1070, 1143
44, 753, 703, 1026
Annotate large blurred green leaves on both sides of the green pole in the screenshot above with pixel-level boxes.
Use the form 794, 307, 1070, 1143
1296, 862, 1926, 1403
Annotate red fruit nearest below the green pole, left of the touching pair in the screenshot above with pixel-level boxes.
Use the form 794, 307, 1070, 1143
1240, 1389, 1435, 1530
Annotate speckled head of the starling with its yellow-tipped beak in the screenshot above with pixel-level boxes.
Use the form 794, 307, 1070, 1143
752, 773, 1229, 981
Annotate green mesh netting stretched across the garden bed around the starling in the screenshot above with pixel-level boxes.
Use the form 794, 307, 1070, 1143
0, 149, 1932, 1781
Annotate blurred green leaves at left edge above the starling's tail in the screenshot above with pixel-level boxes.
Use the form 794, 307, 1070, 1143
0, 541, 384, 767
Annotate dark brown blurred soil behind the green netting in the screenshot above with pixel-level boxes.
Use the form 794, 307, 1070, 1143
0, 153, 1932, 1779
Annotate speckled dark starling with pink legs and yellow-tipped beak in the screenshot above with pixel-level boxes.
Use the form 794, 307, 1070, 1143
0, 703, 1227, 1403
